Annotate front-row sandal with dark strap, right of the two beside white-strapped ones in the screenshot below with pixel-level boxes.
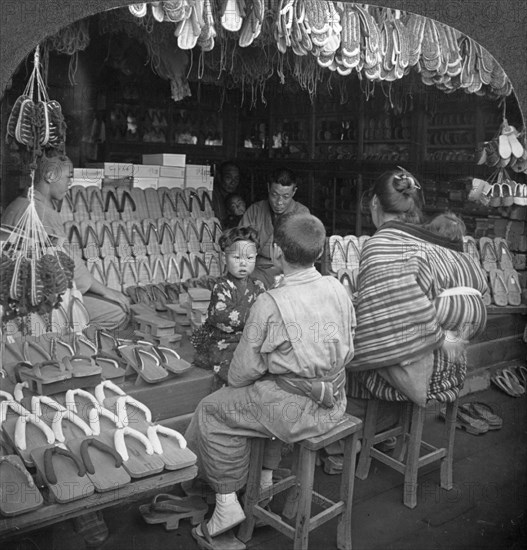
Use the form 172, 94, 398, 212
67, 437, 131, 493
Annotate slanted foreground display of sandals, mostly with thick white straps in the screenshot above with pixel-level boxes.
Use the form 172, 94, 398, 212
0, 380, 196, 517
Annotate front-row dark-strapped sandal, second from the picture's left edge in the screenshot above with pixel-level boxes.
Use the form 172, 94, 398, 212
31, 445, 95, 504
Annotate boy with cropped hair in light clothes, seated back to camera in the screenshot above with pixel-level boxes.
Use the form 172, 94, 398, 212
186, 214, 355, 542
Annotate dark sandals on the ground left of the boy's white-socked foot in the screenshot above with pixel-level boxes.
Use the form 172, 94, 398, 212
139, 493, 209, 531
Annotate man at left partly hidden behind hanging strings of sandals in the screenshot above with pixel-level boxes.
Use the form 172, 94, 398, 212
2, 151, 129, 330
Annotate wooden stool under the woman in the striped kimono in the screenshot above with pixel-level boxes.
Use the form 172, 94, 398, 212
356, 399, 458, 508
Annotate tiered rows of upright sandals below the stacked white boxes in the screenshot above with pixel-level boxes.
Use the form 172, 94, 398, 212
60, 186, 223, 302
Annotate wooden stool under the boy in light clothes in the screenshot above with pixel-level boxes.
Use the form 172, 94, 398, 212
237, 414, 362, 550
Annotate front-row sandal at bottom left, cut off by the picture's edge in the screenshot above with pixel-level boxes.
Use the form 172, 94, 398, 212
0, 455, 44, 517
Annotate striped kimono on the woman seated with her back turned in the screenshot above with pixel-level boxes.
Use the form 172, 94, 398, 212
348, 221, 487, 401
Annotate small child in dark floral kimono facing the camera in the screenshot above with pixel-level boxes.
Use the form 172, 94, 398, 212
191, 227, 265, 391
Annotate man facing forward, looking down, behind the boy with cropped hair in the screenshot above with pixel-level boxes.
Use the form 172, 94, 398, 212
239, 170, 309, 288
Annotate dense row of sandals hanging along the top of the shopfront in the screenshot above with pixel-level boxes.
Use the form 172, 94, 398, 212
129, 0, 512, 96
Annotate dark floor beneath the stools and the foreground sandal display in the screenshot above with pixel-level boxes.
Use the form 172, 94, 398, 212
2, 389, 527, 550
